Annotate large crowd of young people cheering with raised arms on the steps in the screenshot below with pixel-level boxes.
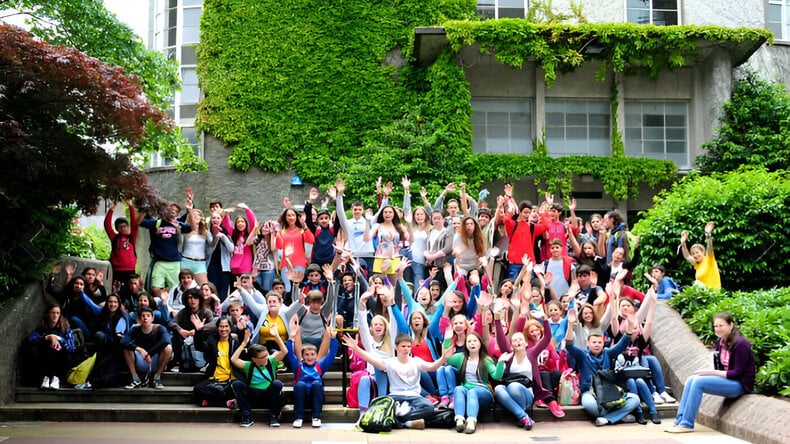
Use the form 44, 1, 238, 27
23, 178, 754, 433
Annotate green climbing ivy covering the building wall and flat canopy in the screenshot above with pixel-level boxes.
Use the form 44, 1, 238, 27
197, 0, 770, 201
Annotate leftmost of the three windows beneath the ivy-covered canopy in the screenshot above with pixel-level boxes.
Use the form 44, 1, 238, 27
472, 99, 533, 154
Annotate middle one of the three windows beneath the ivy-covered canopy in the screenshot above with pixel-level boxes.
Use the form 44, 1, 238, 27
546, 99, 612, 156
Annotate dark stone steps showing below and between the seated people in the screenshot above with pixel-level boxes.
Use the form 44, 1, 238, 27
0, 352, 677, 424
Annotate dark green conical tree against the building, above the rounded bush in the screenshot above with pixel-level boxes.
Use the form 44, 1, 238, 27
697, 72, 790, 173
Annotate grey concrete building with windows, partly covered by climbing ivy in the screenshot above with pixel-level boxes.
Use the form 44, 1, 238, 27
144, 0, 790, 217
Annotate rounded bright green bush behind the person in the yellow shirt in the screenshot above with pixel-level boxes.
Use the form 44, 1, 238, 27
633, 169, 790, 290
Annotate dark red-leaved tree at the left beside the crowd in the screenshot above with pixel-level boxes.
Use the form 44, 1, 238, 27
0, 25, 170, 293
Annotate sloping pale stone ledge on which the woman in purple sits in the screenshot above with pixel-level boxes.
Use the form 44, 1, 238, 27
650, 302, 790, 444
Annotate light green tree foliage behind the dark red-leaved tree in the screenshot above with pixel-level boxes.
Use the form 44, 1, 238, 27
0, 0, 206, 171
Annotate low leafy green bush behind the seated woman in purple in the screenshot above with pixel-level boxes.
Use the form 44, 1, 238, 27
669, 286, 790, 396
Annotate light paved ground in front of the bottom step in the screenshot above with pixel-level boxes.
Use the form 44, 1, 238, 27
0, 421, 746, 444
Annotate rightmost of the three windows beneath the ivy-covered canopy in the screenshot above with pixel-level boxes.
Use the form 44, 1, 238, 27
625, 101, 689, 167
